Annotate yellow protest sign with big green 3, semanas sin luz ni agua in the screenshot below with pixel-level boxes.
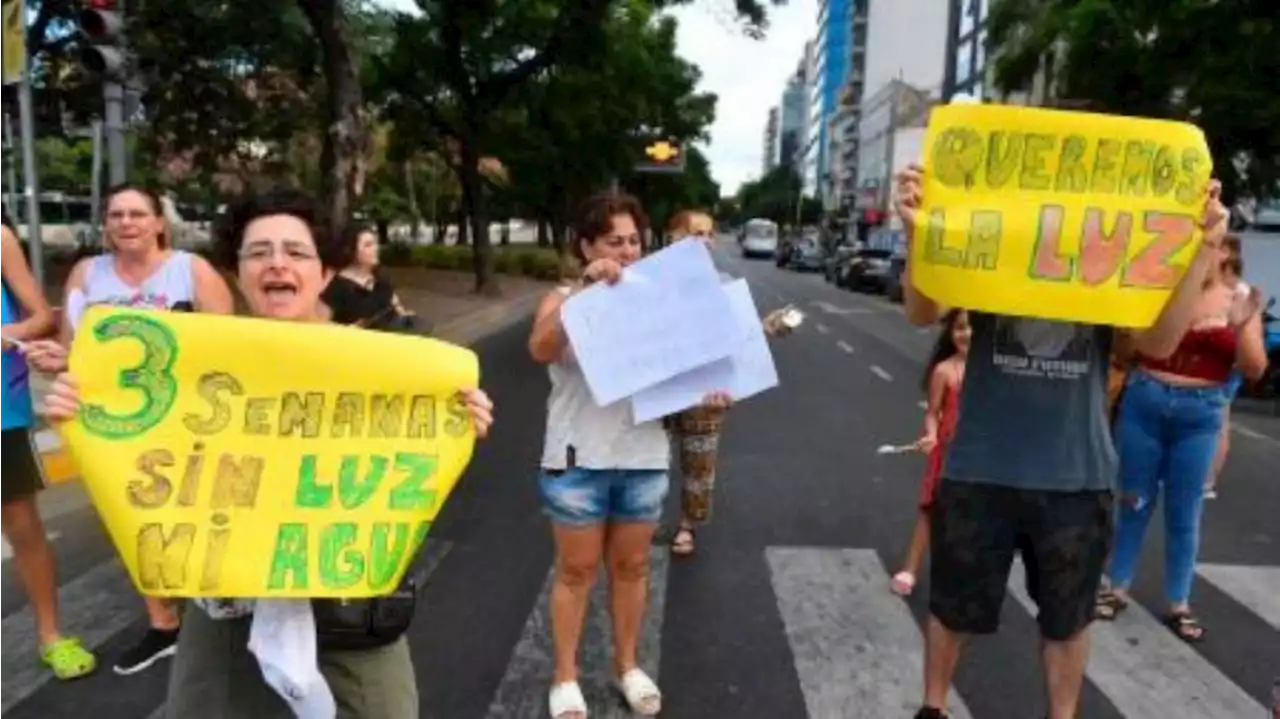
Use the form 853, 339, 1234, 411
61, 307, 479, 597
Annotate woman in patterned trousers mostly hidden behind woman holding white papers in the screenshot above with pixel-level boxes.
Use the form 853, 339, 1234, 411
667, 210, 791, 557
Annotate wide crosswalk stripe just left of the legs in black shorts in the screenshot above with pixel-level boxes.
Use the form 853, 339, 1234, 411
764, 546, 972, 719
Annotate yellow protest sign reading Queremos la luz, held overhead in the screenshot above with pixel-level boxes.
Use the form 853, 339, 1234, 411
910, 105, 1212, 328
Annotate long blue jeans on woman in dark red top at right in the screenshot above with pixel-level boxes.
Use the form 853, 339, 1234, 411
1108, 370, 1228, 605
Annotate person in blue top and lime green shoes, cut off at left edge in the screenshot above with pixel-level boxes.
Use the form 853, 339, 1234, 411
0, 207, 97, 679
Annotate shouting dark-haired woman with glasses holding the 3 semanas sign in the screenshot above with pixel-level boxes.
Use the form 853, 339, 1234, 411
38, 191, 493, 719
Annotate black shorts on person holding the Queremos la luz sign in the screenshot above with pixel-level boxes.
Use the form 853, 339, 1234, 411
929, 480, 1112, 641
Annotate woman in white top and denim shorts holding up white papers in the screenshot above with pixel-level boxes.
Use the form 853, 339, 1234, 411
529, 193, 728, 719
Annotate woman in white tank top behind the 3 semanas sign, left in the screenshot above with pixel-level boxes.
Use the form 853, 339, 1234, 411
27, 184, 234, 674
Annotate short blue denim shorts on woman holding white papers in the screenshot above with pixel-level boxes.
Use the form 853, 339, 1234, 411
538, 467, 671, 527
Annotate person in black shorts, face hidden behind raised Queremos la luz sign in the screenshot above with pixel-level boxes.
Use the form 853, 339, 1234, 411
895, 136, 1226, 719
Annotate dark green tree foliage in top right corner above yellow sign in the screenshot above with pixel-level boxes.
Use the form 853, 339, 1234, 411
989, 0, 1280, 197
